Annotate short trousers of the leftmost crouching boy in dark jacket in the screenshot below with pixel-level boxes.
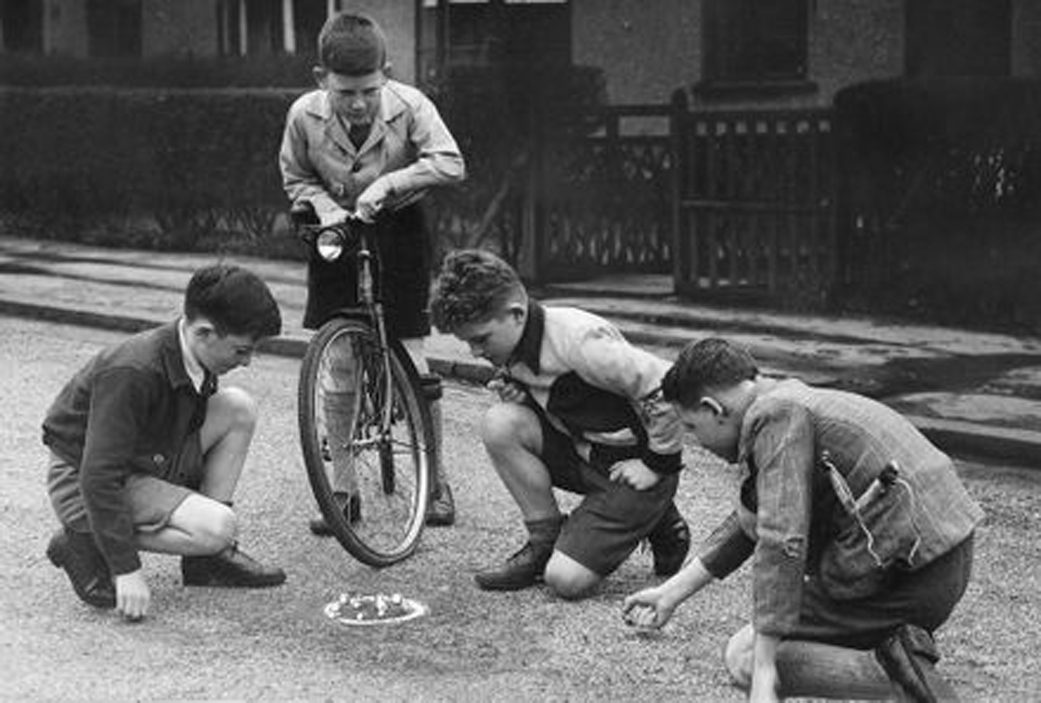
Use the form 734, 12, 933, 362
47, 433, 203, 532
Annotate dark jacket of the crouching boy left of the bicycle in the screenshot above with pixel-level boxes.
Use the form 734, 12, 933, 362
43, 322, 206, 575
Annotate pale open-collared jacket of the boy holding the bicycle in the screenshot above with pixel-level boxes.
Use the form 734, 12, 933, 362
279, 80, 465, 216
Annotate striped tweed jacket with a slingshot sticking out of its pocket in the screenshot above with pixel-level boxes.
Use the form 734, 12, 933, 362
700, 380, 983, 636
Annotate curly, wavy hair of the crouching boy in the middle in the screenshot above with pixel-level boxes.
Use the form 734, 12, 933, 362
430, 249, 527, 333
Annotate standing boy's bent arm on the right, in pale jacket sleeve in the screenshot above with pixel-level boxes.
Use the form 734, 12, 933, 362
377, 89, 466, 204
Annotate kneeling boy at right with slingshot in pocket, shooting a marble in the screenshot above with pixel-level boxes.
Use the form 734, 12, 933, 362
624, 338, 983, 701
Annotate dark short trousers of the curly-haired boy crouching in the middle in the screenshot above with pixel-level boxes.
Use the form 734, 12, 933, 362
535, 409, 679, 576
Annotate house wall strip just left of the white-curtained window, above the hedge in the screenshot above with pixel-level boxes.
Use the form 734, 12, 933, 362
141, 0, 218, 56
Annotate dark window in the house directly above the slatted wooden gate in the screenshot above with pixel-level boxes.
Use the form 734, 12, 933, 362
703, 0, 808, 84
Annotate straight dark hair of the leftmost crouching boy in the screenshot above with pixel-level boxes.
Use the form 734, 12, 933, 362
184, 263, 282, 340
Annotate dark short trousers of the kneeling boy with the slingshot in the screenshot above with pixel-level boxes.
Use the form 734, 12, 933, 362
785, 534, 973, 649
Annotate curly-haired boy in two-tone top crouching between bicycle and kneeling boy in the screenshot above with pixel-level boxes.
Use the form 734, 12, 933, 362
431, 250, 690, 599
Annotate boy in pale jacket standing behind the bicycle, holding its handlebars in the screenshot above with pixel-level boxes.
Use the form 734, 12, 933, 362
279, 14, 465, 534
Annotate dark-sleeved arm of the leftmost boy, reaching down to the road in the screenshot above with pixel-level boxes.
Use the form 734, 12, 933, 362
79, 369, 151, 575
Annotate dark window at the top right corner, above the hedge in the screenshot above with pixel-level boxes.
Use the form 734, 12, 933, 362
906, 0, 1012, 77
